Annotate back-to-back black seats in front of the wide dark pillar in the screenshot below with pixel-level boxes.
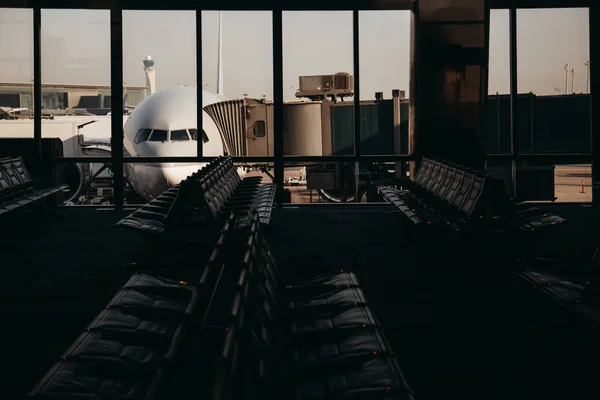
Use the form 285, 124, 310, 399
377, 157, 567, 232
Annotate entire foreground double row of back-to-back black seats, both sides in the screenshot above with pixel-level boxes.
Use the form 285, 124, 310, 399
30, 211, 413, 400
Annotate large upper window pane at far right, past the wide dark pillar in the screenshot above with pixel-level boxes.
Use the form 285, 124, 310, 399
517, 8, 591, 154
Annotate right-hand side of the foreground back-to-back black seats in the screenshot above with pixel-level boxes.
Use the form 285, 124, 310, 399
213, 211, 413, 400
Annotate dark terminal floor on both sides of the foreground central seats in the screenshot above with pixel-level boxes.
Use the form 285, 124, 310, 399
0, 205, 600, 399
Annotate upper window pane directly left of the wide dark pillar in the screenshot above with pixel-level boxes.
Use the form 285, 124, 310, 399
359, 11, 411, 155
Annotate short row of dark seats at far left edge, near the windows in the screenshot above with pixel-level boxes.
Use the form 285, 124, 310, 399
0, 157, 69, 220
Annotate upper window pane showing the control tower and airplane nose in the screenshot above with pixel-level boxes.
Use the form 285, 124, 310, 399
123, 10, 197, 161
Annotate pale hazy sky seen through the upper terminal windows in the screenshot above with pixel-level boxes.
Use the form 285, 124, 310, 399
0, 9, 589, 99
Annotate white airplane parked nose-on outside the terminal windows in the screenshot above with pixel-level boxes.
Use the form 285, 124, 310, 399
81, 86, 225, 201
